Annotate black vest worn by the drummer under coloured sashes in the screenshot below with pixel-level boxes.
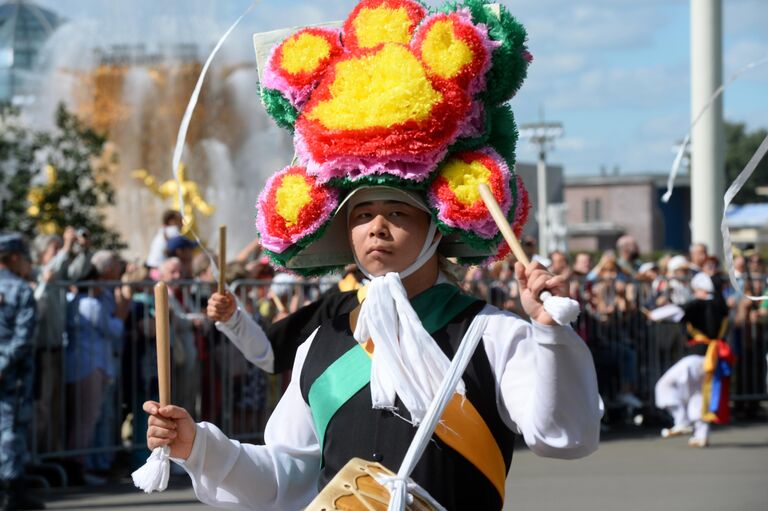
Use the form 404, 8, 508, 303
300, 302, 514, 510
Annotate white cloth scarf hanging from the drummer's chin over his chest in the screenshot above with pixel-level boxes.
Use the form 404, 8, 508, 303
354, 272, 465, 425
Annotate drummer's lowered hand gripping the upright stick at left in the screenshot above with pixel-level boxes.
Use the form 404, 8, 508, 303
143, 401, 197, 460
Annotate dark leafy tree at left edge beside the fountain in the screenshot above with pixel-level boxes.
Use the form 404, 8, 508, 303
0, 105, 125, 249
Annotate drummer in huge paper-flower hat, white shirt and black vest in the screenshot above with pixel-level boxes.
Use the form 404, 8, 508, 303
145, 0, 602, 510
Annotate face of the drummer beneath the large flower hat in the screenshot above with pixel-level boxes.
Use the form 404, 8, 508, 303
347, 200, 429, 276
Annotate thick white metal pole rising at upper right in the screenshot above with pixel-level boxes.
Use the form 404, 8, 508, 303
691, 0, 725, 257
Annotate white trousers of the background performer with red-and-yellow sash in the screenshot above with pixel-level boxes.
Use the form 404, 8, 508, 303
656, 355, 709, 440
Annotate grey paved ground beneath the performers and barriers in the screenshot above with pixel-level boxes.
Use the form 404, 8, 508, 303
44, 423, 768, 511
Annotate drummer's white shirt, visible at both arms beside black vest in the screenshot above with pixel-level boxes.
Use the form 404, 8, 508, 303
175, 305, 602, 511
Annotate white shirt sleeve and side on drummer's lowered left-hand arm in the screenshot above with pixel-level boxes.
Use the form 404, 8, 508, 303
174, 330, 320, 511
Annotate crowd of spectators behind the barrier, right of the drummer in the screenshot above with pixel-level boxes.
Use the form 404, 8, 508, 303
462, 236, 768, 417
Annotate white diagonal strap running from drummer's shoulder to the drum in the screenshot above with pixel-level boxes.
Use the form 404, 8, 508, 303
388, 314, 488, 511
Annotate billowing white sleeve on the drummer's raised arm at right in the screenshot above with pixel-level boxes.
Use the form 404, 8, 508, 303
482, 306, 603, 459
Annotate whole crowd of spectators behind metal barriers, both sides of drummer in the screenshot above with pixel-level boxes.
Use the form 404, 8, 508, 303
1, 211, 768, 488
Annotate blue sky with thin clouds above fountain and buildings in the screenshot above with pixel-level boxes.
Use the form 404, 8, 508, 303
30, 0, 768, 175
